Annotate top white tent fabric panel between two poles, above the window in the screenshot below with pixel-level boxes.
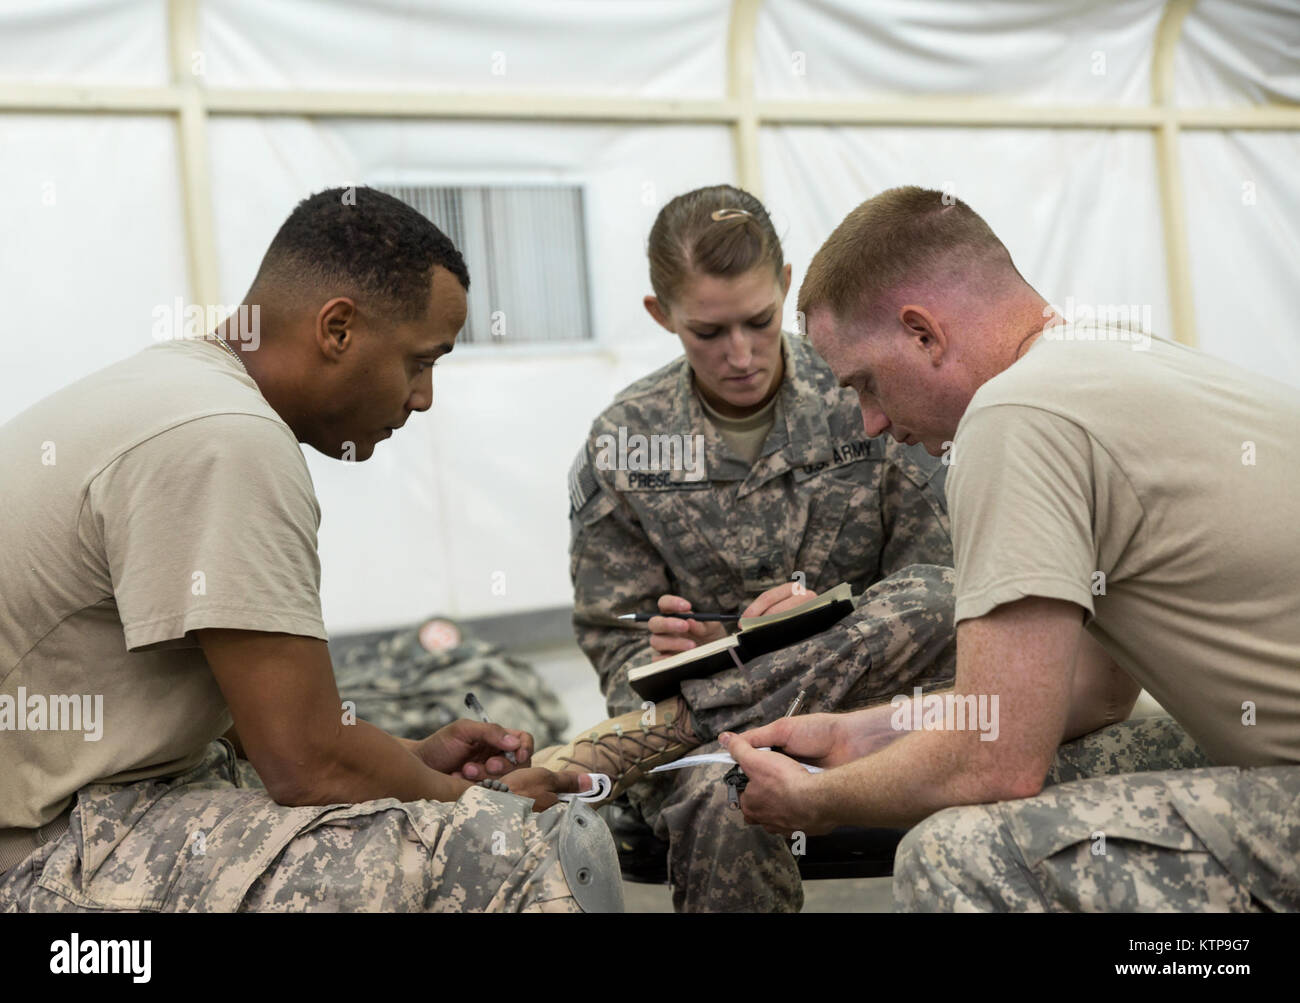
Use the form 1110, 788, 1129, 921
200, 0, 729, 97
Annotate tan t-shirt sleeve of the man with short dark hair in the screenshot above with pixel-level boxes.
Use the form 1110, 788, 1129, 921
87, 414, 328, 650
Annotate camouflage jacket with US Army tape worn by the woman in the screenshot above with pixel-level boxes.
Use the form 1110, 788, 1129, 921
569, 335, 953, 713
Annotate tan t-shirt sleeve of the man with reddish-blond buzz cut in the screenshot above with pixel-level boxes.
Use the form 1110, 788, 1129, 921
948, 404, 1097, 621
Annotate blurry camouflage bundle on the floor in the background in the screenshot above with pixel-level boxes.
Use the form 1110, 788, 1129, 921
329, 628, 569, 748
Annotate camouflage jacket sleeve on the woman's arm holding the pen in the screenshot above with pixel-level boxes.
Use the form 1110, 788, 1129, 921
569, 436, 668, 715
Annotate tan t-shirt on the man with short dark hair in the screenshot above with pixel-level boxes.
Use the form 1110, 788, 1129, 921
0, 342, 328, 828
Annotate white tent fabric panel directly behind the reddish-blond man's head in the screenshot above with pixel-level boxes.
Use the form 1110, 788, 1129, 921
762, 126, 1169, 333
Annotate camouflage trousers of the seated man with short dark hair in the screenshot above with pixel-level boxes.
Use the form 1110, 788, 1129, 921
0, 741, 621, 912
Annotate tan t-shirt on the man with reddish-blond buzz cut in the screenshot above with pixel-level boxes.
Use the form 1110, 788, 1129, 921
948, 336, 1300, 767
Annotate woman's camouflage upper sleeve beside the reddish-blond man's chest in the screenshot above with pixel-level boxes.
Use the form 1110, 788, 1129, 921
880, 439, 953, 578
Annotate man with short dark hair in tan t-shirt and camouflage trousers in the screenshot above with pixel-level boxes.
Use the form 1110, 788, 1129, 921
0, 188, 621, 911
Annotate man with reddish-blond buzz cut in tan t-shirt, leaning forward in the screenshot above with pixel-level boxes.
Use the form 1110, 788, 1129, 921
722, 187, 1300, 911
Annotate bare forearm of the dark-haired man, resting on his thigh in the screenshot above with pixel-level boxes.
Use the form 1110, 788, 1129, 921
268, 721, 473, 806
